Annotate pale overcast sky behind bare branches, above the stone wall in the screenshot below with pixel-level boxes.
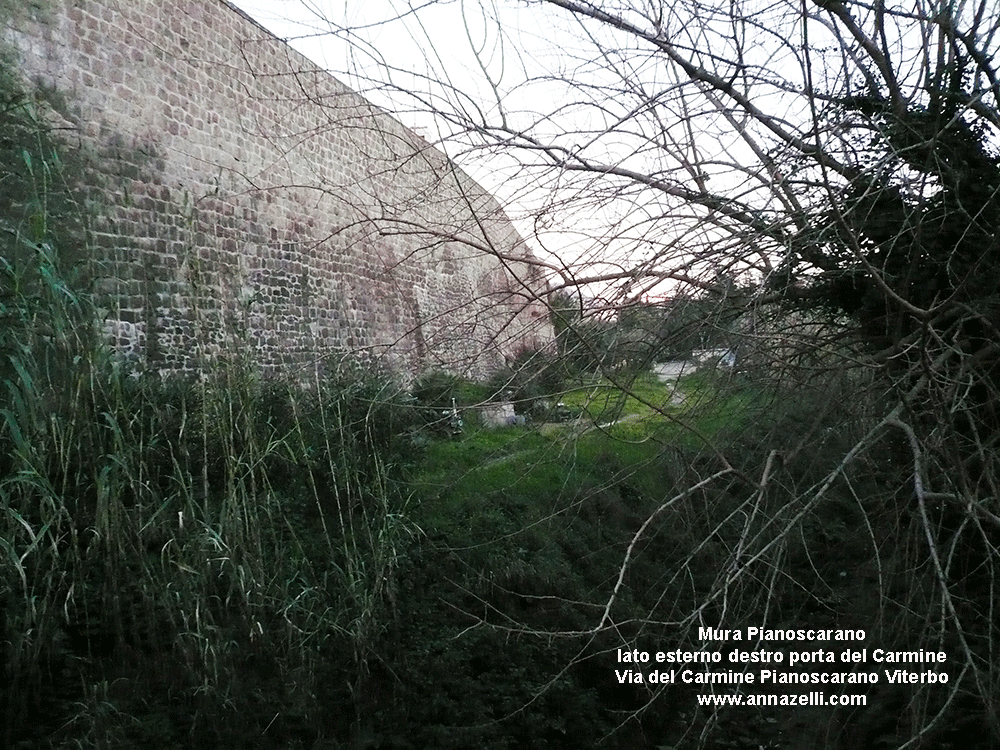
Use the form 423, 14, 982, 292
219, 0, 996, 302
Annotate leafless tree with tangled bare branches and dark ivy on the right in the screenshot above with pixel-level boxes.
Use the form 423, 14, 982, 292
278, 0, 1000, 746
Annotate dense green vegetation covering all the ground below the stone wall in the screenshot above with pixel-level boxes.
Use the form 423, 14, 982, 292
0, 33, 998, 750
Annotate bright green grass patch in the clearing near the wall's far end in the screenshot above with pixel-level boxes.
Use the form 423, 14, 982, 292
412, 374, 696, 532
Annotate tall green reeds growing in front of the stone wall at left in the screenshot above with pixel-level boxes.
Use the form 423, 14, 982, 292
0, 85, 417, 748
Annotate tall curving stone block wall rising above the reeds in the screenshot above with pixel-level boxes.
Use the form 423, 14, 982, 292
6, 0, 551, 375
